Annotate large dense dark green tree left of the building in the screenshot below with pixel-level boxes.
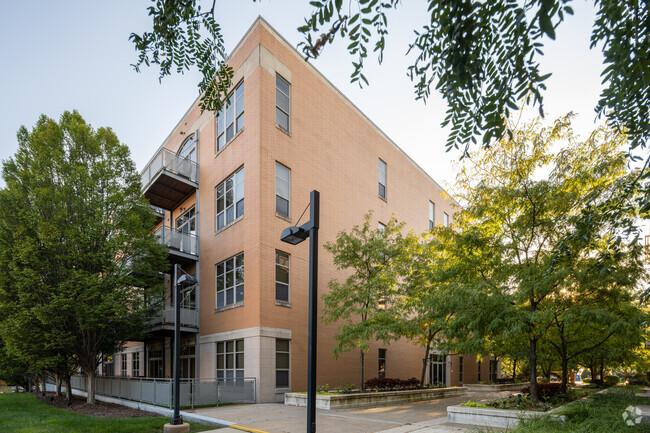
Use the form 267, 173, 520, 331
0, 111, 166, 403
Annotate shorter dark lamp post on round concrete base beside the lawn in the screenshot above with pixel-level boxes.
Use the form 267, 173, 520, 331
163, 264, 199, 433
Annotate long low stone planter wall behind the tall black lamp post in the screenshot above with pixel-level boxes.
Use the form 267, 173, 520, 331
284, 387, 467, 410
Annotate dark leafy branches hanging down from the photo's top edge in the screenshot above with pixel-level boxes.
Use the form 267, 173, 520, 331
131, 0, 650, 159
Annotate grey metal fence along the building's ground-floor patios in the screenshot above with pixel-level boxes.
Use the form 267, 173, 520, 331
70, 375, 256, 409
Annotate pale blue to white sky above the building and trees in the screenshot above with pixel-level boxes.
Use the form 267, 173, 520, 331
0, 0, 603, 191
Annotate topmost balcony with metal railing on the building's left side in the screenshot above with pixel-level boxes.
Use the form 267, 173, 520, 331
141, 148, 199, 210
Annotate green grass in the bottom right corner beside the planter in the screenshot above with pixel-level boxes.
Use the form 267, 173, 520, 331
487, 386, 650, 433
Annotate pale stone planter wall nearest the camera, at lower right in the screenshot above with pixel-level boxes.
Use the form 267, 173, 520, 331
447, 406, 565, 429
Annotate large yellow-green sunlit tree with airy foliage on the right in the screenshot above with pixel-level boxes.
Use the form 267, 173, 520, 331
440, 115, 640, 399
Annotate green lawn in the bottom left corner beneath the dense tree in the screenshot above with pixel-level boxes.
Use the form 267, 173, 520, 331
0, 393, 217, 433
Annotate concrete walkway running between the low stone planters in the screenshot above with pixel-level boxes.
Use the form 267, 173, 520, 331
186, 391, 512, 433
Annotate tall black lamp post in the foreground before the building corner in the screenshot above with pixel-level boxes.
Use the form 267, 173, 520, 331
281, 190, 320, 433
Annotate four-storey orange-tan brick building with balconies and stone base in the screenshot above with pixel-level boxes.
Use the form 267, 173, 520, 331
102, 18, 496, 402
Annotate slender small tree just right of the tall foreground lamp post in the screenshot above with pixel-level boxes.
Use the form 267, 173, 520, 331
322, 213, 403, 390
